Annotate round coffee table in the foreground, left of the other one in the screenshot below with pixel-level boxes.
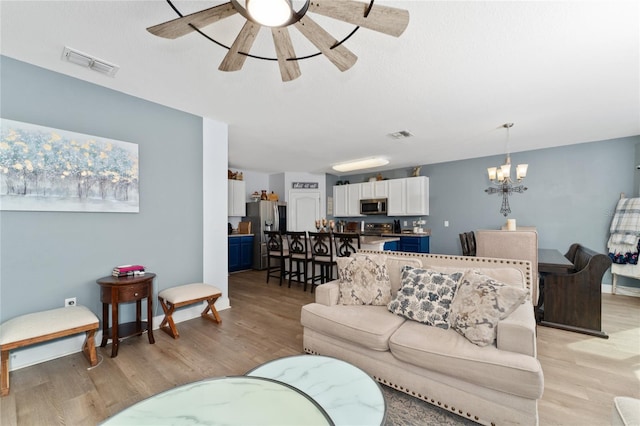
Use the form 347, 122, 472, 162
102, 376, 333, 426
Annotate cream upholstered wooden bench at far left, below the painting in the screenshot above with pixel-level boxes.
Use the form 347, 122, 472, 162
0, 306, 99, 396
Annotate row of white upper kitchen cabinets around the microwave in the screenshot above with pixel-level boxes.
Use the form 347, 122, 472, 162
333, 176, 429, 217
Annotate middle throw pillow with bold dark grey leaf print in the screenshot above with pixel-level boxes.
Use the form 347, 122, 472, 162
388, 266, 462, 330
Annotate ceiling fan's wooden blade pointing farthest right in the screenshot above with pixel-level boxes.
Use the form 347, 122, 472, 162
309, 0, 409, 37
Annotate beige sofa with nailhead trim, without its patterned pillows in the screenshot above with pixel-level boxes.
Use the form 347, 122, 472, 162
301, 250, 544, 425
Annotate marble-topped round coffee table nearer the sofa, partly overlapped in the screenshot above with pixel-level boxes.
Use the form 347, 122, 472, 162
246, 355, 387, 426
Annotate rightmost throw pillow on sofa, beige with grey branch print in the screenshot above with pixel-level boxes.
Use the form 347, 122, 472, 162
449, 271, 527, 346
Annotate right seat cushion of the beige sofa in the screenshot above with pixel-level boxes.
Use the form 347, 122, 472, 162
389, 321, 544, 399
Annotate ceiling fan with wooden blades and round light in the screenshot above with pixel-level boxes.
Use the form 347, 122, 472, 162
147, 0, 409, 81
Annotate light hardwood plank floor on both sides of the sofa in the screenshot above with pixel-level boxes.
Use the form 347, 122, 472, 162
0, 271, 640, 426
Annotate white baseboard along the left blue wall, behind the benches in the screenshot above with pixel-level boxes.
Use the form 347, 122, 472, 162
4, 297, 231, 371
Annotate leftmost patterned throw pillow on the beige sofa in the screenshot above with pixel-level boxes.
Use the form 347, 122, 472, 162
336, 256, 391, 306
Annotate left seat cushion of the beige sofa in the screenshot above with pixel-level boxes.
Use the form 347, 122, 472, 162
300, 303, 405, 351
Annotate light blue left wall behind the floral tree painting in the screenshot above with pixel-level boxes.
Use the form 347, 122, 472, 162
0, 56, 203, 320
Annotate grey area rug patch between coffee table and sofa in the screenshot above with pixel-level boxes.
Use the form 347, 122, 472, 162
380, 385, 477, 426
